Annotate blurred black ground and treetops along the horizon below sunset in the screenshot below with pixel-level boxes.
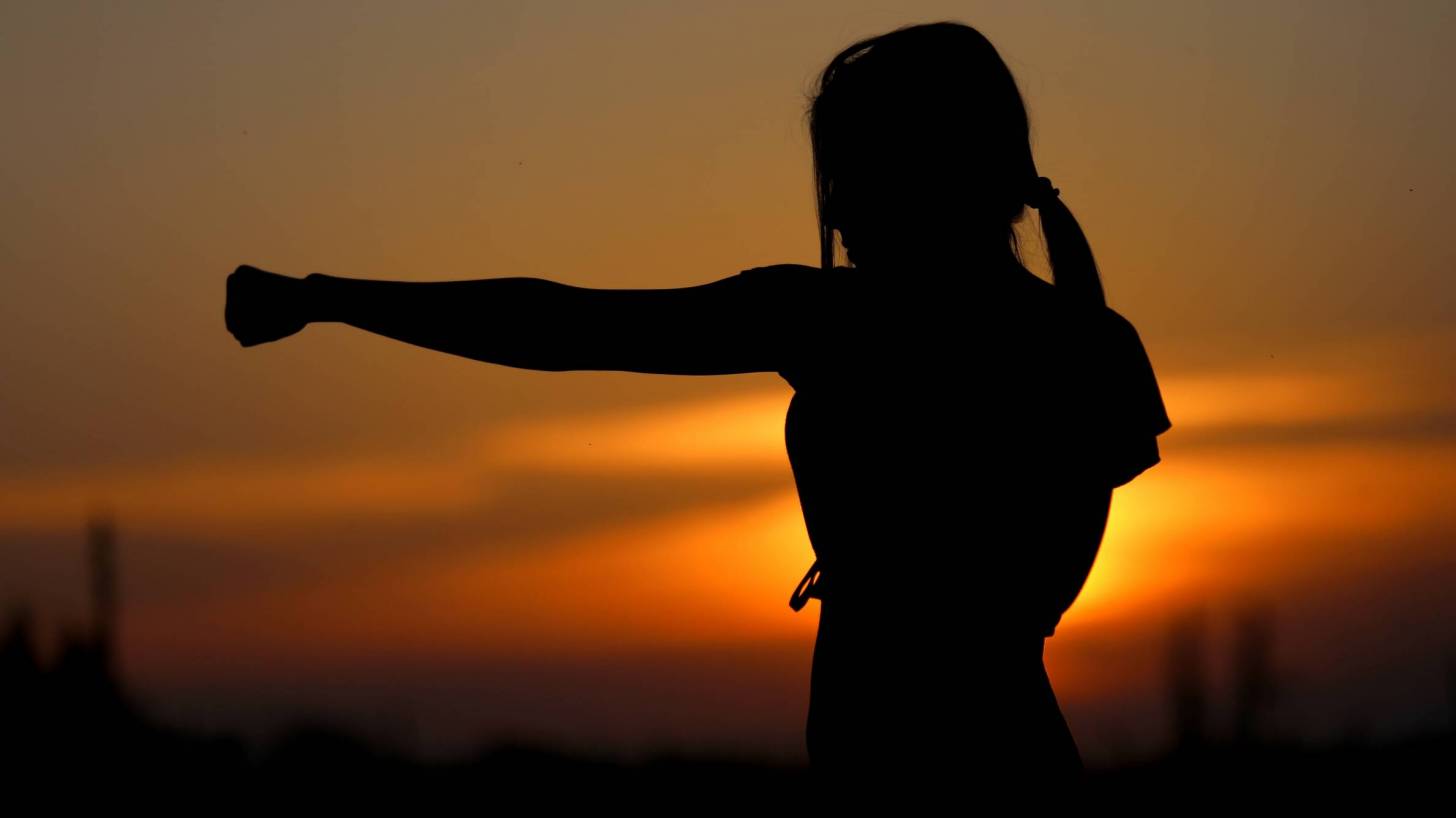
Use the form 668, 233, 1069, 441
0, 512, 1456, 809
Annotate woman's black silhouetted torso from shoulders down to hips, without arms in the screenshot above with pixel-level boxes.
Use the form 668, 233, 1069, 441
783, 260, 1105, 769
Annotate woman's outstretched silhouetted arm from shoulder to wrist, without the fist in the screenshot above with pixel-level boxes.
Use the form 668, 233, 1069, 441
230, 265, 794, 376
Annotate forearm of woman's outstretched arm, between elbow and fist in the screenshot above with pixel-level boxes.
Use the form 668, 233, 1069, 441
303, 272, 584, 371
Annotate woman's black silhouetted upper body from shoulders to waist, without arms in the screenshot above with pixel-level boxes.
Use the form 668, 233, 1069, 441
783, 259, 1106, 622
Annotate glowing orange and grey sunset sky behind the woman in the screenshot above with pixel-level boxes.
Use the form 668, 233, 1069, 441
0, 0, 1456, 761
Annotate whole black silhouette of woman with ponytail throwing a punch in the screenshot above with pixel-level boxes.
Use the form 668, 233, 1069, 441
226, 22, 1171, 792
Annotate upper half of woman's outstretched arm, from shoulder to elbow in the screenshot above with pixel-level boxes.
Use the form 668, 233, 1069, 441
547, 265, 817, 376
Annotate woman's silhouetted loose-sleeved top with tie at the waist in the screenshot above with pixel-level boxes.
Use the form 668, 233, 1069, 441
738, 265, 1172, 636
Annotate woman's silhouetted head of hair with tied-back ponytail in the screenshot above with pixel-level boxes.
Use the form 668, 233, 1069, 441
805, 22, 1105, 304
